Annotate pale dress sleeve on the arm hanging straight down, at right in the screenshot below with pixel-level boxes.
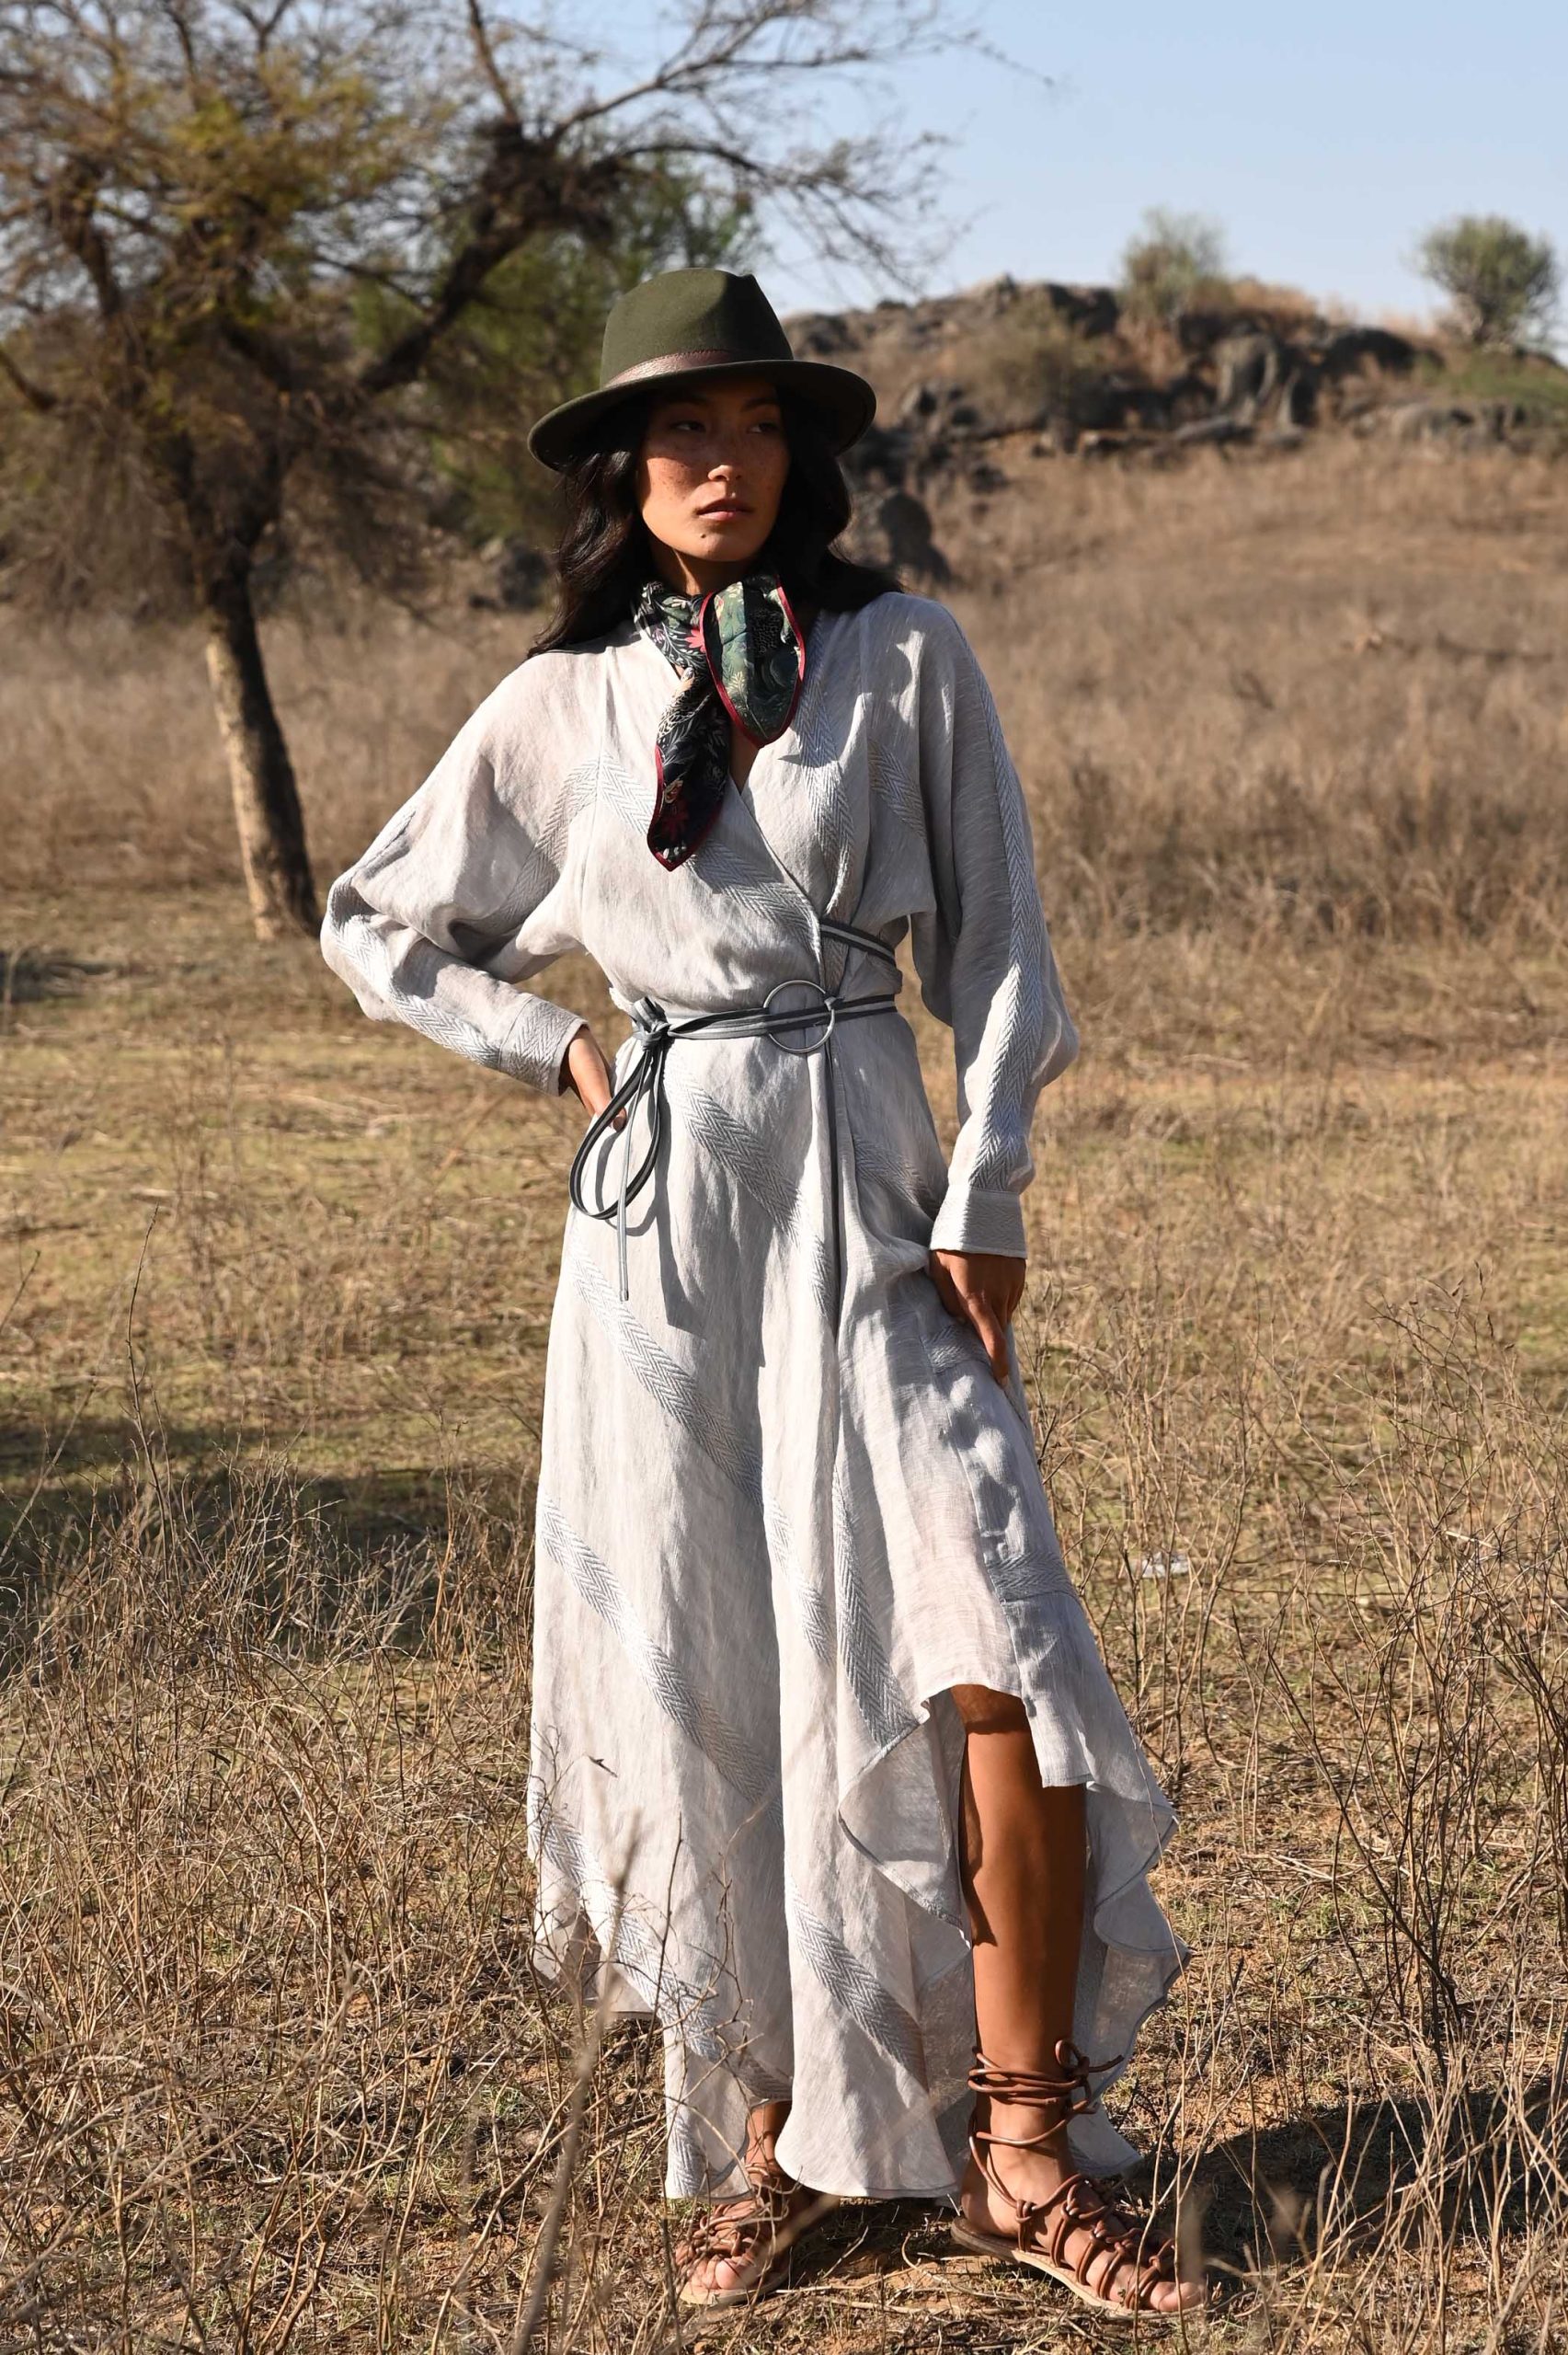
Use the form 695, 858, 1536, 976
911, 607, 1079, 1258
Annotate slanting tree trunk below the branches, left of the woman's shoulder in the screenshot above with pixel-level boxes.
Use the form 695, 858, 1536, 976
202, 565, 320, 939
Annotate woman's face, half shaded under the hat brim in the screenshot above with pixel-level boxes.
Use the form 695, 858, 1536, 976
638, 377, 789, 593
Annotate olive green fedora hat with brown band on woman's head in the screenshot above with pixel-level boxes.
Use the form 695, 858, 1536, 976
527, 270, 876, 471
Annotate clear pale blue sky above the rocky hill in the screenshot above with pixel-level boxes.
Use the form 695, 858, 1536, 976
743, 0, 1568, 349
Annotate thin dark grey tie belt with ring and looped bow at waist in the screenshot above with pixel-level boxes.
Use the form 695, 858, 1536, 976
567, 916, 899, 1316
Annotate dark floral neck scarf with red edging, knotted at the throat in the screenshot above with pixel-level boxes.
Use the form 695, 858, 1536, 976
631, 570, 806, 869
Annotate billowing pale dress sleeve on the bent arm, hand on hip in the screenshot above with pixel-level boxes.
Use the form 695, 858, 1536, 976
320, 664, 593, 1095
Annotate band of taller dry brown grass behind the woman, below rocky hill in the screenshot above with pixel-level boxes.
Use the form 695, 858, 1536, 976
0, 442, 1568, 947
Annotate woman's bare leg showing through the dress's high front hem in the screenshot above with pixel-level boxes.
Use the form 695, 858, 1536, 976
954, 1683, 1203, 2313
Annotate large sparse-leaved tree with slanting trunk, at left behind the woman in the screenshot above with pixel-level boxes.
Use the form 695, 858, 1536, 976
0, 0, 972, 937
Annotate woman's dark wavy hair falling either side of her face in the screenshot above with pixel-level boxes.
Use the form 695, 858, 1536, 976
527, 386, 904, 655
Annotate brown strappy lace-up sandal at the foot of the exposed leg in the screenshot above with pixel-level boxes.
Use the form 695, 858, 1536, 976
951, 2037, 1196, 2322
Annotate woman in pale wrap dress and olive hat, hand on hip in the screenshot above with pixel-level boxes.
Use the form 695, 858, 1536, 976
323, 270, 1203, 2313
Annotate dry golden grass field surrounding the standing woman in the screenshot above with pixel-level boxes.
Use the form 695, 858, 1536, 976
0, 445, 1568, 2355
